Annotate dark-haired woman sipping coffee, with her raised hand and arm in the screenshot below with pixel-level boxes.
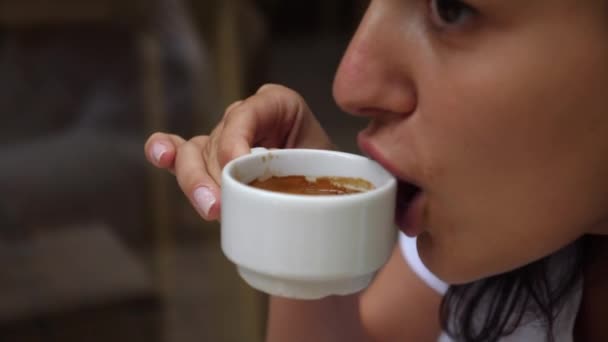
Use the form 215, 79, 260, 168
146, 0, 608, 341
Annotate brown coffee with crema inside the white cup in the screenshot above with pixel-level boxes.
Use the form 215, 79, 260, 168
249, 176, 374, 195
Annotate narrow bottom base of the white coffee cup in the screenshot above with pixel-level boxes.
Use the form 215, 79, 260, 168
237, 266, 375, 300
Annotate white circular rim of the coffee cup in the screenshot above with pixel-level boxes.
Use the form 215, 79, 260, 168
222, 148, 397, 202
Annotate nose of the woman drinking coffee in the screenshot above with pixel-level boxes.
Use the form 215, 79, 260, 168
333, 1, 417, 117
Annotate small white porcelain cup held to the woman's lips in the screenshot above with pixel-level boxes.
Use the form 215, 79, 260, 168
221, 148, 397, 299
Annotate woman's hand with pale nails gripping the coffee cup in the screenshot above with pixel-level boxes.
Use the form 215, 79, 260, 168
145, 84, 332, 220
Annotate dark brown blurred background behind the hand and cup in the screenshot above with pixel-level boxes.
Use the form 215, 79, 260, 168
0, 0, 366, 342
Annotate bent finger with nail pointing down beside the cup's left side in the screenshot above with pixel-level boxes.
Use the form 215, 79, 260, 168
175, 136, 220, 221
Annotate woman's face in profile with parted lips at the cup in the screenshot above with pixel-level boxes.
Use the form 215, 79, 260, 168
334, 0, 608, 283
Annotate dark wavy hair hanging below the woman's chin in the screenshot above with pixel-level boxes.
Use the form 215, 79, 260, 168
440, 237, 586, 342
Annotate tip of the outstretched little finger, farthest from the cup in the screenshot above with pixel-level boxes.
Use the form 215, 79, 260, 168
144, 133, 185, 170
